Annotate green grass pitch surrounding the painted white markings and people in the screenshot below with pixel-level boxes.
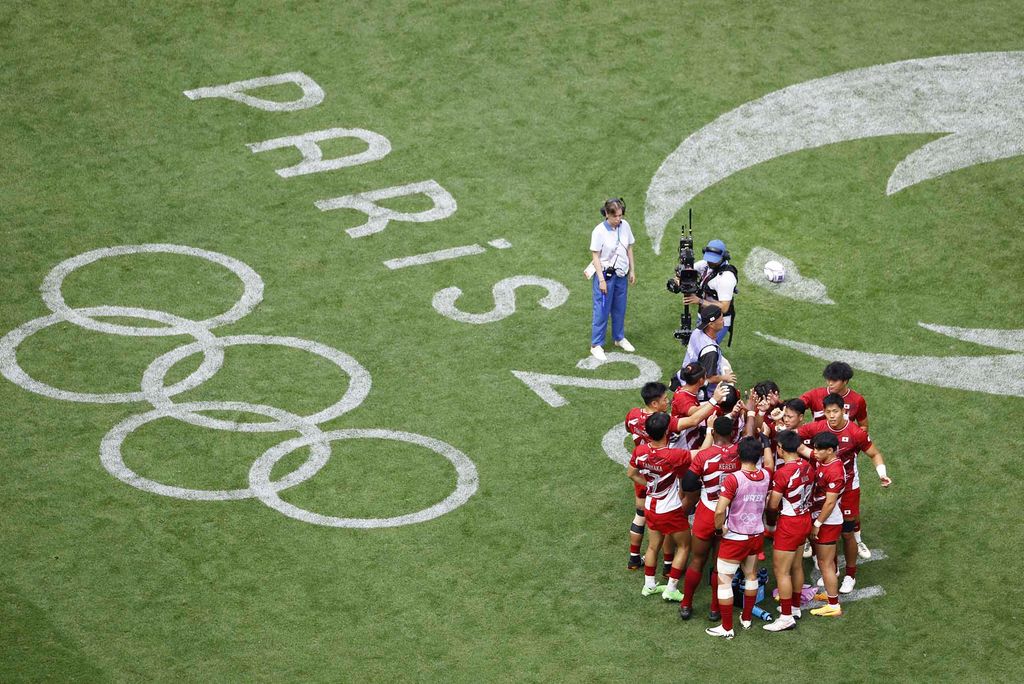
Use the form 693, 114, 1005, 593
0, 0, 1024, 682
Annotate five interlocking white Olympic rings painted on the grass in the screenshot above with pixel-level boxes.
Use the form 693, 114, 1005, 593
0, 245, 478, 528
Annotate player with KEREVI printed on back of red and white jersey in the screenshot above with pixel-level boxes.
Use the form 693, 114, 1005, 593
679, 416, 739, 621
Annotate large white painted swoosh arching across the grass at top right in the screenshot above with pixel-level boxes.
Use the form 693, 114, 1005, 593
644, 52, 1024, 254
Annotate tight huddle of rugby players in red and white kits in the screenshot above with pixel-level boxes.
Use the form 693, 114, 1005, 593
626, 361, 892, 639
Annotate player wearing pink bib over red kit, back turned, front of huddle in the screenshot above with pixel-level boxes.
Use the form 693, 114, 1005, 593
705, 436, 771, 639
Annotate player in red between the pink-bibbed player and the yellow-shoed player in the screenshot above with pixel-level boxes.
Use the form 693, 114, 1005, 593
764, 430, 814, 632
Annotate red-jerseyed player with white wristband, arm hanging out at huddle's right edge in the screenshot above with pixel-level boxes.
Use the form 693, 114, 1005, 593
798, 394, 892, 594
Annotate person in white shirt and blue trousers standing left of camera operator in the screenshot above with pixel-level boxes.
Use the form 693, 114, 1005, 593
590, 198, 637, 361
